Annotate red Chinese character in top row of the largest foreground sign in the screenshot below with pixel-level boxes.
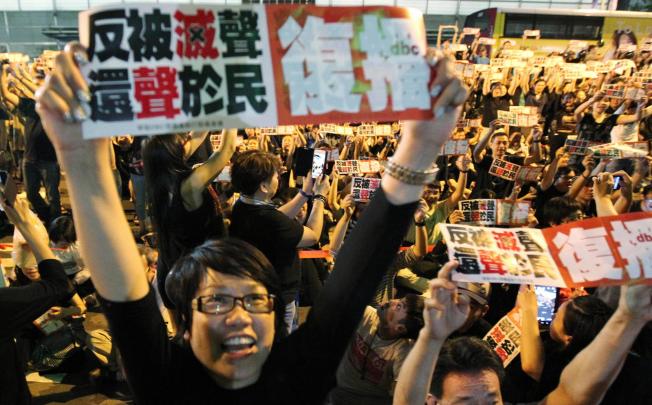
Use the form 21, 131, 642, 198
174, 9, 219, 59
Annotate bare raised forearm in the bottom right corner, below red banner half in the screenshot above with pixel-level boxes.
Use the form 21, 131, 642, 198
541, 285, 652, 405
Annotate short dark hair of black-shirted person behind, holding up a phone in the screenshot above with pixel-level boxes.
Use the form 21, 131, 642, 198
231, 150, 281, 195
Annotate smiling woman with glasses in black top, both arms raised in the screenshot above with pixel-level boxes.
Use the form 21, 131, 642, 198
33, 45, 467, 405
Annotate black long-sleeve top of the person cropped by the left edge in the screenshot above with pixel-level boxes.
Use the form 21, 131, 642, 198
0, 259, 74, 405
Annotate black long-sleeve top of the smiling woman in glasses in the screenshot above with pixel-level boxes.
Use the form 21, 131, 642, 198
104, 190, 416, 405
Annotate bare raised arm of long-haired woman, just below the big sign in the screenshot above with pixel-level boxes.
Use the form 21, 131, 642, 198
181, 129, 238, 211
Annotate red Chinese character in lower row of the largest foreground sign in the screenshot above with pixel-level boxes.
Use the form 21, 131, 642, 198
134, 66, 180, 118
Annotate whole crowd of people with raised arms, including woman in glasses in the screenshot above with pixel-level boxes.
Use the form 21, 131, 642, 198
0, 24, 652, 405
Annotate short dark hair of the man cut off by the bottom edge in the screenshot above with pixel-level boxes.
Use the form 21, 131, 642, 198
430, 336, 505, 398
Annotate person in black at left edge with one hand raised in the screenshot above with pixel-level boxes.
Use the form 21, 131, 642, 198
0, 197, 74, 405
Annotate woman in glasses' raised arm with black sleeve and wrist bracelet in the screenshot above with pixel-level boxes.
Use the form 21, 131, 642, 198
304, 51, 467, 368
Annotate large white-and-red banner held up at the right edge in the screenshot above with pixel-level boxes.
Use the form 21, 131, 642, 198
440, 212, 652, 287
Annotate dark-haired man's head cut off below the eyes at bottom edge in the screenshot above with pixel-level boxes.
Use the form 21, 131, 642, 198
428, 337, 505, 404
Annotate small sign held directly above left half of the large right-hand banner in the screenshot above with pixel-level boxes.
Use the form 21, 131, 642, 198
458, 199, 530, 226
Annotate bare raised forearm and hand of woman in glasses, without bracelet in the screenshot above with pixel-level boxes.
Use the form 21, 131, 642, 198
36, 45, 149, 302
